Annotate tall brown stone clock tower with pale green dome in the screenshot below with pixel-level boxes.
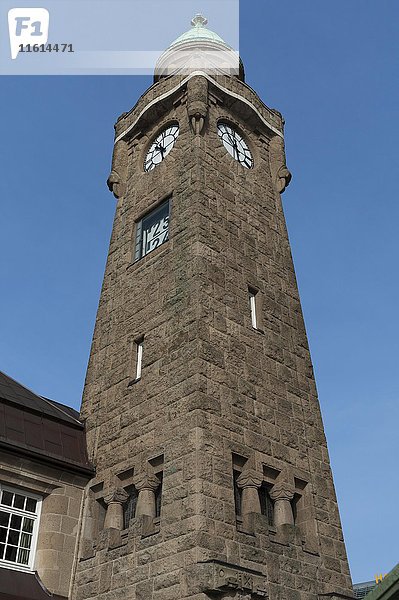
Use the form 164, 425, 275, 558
72, 15, 351, 600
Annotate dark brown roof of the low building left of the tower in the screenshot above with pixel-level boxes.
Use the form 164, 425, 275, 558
0, 372, 93, 474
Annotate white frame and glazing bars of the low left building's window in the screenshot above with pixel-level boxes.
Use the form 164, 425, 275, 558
0, 482, 43, 572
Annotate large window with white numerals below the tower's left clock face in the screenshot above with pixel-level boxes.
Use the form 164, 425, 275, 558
134, 200, 169, 261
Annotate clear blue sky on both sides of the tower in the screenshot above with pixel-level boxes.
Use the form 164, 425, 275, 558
0, 0, 399, 582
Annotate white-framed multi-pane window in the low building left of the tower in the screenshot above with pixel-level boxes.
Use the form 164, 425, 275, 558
0, 484, 41, 570
